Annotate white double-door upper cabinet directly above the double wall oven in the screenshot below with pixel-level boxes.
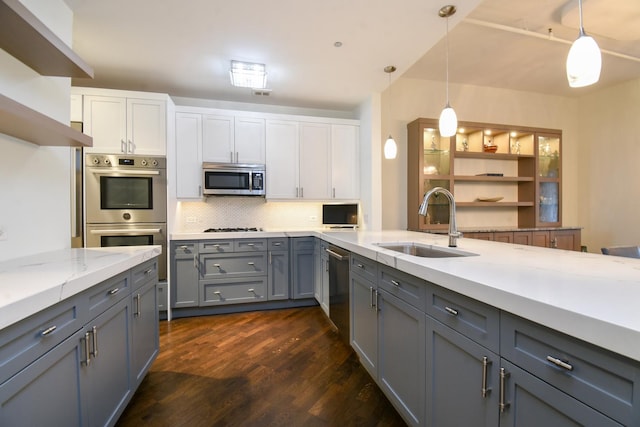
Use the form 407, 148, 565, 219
83, 94, 167, 155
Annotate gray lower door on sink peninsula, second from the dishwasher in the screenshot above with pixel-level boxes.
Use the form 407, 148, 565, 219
378, 290, 426, 426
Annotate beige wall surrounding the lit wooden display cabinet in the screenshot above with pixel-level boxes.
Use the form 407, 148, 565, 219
380, 78, 583, 237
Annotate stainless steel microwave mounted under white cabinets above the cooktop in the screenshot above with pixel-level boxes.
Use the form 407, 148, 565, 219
202, 162, 265, 196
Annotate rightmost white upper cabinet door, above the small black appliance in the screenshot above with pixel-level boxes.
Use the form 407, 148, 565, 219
331, 125, 360, 200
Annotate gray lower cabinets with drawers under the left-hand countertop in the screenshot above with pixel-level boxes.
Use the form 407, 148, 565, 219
0, 260, 158, 426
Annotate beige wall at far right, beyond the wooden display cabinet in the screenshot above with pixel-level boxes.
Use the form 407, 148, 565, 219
577, 79, 640, 252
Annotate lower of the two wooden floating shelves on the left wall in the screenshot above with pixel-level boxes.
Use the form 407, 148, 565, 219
0, 95, 93, 147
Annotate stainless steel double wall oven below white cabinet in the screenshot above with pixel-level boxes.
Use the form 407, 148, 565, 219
85, 153, 167, 280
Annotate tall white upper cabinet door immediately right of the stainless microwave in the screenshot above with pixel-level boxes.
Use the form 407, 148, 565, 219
266, 120, 299, 199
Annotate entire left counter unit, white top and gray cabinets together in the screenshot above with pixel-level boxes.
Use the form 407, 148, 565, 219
0, 246, 161, 426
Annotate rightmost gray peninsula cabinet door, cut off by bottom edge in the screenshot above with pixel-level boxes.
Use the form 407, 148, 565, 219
500, 359, 622, 427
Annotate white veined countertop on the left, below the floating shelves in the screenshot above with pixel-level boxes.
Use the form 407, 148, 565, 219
0, 246, 162, 329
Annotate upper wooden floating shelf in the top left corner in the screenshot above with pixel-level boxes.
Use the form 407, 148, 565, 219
0, 0, 93, 78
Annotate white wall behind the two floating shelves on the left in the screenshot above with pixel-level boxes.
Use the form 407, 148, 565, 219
0, 0, 73, 260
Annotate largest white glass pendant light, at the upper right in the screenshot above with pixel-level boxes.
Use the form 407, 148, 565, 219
567, 0, 602, 87
